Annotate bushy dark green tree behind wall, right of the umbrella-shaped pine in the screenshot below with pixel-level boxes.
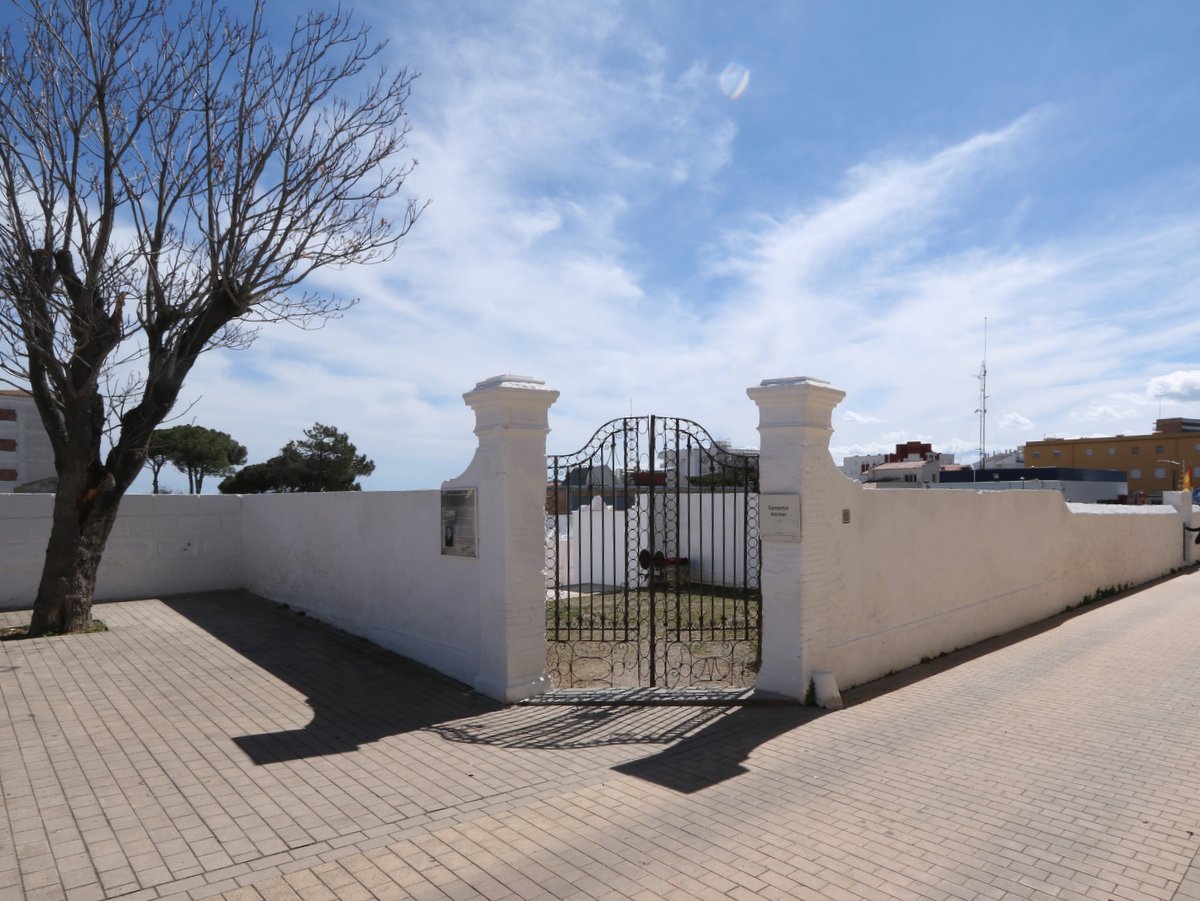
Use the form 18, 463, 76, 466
218, 422, 374, 494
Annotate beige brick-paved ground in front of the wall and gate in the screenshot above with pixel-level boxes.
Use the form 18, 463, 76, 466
0, 573, 1200, 901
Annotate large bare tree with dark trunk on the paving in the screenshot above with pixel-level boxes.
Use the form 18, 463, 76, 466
0, 0, 421, 635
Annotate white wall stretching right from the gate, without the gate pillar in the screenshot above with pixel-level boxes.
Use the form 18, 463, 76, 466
816, 482, 1182, 686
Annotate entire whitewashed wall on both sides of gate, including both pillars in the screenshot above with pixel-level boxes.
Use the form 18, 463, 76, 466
0, 377, 1200, 701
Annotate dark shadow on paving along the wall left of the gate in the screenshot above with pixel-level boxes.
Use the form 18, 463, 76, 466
162, 591, 503, 764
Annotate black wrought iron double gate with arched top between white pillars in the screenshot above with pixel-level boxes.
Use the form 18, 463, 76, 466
546, 416, 762, 689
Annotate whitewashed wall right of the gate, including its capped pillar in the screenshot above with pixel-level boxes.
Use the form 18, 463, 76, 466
749, 378, 1195, 697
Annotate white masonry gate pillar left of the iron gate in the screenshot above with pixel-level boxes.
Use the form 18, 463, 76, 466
445, 376, 558, 703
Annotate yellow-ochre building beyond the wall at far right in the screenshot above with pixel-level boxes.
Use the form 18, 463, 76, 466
1025, 418, 1200, 499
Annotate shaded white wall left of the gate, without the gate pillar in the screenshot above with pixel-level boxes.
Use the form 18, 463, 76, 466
0, 491, 480, 683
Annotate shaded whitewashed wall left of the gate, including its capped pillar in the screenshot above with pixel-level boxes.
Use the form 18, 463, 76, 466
0, 376, 558, 701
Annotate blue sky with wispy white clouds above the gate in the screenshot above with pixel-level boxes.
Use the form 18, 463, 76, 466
139, 0, 1200, 489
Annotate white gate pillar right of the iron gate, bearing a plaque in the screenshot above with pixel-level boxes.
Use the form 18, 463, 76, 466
746, 377, 846, 698
